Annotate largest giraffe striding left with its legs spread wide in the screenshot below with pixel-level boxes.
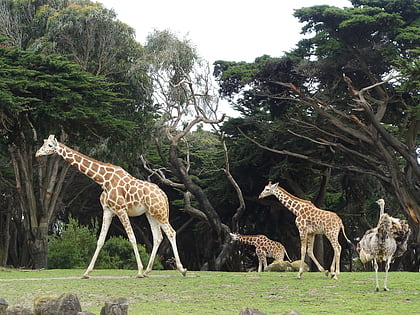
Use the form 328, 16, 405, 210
35, 135, 187, 279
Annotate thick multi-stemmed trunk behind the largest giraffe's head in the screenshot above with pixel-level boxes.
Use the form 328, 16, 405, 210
9, 132, 69, 269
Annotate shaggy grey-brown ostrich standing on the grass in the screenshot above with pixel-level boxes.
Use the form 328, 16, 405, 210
357, 199, 410, 291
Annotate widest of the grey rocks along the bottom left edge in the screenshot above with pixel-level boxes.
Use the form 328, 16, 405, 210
34, 293, 82, 315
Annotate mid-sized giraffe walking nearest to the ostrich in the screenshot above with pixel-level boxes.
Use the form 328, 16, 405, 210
259, 182, 352, 280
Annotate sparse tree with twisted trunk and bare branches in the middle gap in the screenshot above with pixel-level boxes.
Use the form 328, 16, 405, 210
139, 31, 244, 270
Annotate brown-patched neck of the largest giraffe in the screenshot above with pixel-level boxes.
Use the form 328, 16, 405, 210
57, 143, 113, 185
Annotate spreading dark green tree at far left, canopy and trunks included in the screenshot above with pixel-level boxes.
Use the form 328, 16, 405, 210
0, 46, 135, 268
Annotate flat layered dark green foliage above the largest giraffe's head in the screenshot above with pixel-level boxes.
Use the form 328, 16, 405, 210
0, 43, 134, 141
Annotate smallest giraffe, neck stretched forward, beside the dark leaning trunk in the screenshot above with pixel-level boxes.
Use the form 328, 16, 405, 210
230, 233, 290, 272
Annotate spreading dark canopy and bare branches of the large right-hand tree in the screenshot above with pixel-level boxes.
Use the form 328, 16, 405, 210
215, 0, 420, 223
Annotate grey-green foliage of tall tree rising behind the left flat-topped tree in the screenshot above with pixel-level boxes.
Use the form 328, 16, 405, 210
0, 0, 154, 164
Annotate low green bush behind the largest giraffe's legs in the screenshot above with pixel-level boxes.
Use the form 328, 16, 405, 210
48, 217, 163, 270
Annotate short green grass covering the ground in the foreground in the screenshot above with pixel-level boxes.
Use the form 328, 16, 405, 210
0, 270, 420, 315
